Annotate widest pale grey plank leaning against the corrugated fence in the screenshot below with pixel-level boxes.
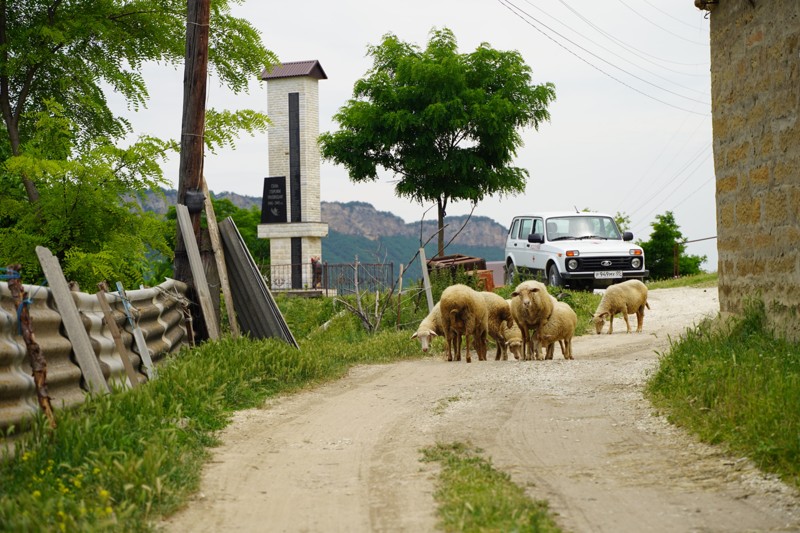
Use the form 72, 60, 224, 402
36, 246, 110, 394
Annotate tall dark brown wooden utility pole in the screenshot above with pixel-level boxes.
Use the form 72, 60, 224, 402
173, 0, 211, 339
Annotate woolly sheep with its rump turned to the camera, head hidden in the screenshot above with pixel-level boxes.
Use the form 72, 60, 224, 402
439, 284, 489, 363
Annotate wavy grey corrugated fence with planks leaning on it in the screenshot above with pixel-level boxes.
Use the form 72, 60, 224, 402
0, 280, 188, 434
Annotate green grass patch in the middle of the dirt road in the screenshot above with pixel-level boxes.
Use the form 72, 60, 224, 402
421, 443, 561, 532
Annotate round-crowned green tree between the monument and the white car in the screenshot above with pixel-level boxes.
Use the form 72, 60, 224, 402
320, 29, 555, 254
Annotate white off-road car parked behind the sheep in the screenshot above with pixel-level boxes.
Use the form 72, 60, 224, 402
505, 211, 649, 290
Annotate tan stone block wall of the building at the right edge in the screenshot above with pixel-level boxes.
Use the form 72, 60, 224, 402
712, 0, 800, 340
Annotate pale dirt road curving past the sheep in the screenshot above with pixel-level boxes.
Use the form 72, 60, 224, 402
162, 288, 800, 533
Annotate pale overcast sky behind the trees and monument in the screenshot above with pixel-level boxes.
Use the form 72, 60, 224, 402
119, 0, 717, 270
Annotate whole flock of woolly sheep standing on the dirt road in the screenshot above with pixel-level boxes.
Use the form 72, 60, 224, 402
411, 280, 650, 363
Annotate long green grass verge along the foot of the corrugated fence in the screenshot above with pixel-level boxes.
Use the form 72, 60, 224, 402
0, 304, 432, 532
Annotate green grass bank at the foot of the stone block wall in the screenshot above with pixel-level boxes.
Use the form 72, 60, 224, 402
647, 303, 800, 487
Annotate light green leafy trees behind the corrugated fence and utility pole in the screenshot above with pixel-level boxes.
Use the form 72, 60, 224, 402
0, 0, 274, 288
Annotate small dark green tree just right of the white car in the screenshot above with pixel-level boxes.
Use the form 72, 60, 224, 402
637, 211, 706, 279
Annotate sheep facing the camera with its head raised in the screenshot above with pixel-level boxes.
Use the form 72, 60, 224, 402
511, 280, 556, 360
